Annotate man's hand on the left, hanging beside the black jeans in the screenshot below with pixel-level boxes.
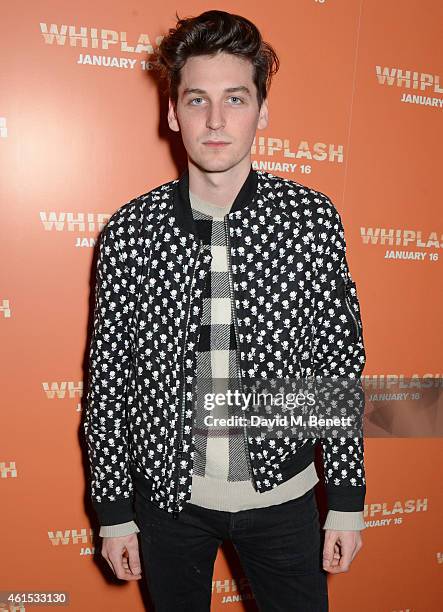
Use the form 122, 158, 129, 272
102, 533, 141, 580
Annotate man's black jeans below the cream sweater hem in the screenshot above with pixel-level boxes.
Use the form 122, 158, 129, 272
135, 489, 328, 612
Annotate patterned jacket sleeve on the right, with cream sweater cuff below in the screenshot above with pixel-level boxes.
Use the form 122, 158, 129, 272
313, 196, 366, 516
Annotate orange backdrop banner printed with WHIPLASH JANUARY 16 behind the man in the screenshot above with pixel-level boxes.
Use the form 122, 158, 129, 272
0, 0, 443, 612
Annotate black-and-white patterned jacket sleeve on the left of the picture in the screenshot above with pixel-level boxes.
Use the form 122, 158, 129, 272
83, 211, 136, 525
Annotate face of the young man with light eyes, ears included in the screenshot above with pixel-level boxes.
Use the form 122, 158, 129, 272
168, 53, 268, 172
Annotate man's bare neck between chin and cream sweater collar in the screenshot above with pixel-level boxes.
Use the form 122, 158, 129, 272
188, 156, 251, 207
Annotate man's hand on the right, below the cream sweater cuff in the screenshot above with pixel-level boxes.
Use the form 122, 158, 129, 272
323, 529, 363, 574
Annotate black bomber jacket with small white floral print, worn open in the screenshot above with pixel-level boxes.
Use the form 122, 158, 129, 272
83, 167, 366, 525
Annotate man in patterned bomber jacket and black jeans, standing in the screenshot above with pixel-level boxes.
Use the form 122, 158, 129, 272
84, 10, 366, 612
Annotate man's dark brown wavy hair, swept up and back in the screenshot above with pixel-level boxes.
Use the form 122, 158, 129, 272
153, 10, 280, 108
